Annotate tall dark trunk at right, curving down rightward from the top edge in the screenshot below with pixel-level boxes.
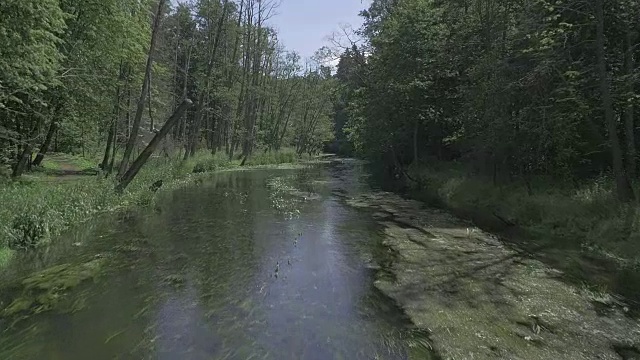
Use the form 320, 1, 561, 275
595, 0, 634, 202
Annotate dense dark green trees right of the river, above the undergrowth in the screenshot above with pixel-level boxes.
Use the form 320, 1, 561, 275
336, 0, 640, 201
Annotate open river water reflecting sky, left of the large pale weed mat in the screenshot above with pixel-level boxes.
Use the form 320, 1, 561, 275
0, 160, 432, 360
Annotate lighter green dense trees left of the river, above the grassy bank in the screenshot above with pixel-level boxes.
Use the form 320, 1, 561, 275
0, 0, 336, 184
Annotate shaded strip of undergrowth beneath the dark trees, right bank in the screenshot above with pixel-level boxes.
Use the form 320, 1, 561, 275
410, 167, 640, 263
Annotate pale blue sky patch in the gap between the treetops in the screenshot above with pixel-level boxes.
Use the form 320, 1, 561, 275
268, 0, 370, 59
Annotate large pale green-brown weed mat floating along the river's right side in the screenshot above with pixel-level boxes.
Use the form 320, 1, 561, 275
347, 193, 640, 360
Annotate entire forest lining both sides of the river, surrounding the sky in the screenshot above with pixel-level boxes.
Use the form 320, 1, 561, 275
0, 0, 640, 257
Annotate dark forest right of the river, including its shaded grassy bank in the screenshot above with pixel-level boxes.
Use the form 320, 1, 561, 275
335, 0, 640, 258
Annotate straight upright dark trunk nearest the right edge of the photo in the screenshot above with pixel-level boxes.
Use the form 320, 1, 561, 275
624, 30, 637, 179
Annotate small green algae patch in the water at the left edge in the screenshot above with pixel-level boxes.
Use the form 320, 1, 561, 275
0, 259, 104, 317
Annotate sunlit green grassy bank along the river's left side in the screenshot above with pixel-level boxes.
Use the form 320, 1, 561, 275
0, 150, 299, 267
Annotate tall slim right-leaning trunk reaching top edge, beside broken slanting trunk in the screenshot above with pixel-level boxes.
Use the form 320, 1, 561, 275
118, 0, 166, 177
